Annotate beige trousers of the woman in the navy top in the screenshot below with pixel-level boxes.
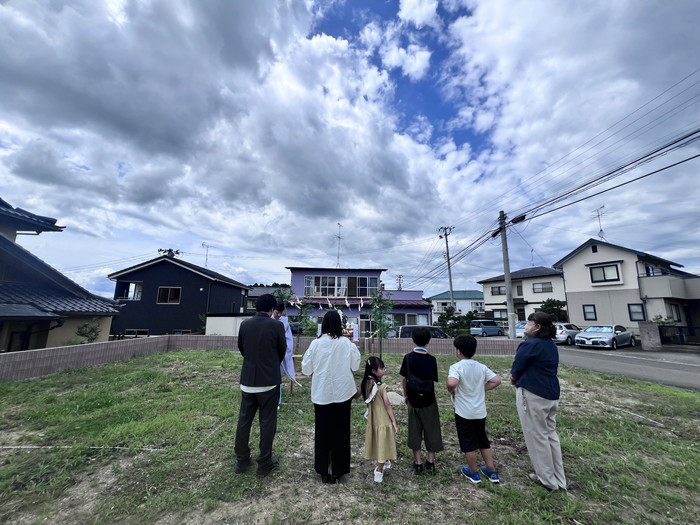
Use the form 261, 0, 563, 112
515, 388, 566, 490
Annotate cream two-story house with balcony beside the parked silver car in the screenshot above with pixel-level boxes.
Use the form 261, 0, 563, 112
554, 239, 700, 333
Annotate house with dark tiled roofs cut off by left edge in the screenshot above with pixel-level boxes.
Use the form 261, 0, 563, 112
0, 199, 119, 352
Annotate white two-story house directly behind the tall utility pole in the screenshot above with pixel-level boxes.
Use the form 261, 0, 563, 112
478, 266, 574, 322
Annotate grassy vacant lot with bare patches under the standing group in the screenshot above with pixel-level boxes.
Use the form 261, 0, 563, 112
0, 351, 700, 525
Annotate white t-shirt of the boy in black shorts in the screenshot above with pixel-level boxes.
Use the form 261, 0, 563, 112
447, 359, 496, 419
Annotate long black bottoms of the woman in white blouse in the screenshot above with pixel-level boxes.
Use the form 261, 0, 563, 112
314, 398, 352, 478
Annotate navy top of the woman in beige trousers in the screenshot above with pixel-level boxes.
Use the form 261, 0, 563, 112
510, 337, 559, 400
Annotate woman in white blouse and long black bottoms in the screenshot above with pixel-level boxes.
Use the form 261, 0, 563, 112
301, 310, 360, 483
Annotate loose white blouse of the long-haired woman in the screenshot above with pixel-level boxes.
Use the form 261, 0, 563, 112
301, 334, 360, 405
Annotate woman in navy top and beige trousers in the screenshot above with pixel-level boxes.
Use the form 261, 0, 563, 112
510, 312, 566, 490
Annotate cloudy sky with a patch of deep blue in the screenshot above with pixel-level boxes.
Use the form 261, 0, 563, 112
0, 0, 700, 296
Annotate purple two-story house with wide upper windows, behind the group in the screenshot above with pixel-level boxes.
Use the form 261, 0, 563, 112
287, 266, 432, 336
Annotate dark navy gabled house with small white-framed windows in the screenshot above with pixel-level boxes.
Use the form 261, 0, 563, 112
108, 250, 250, 336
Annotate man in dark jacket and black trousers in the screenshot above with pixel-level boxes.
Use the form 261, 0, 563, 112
234, 294, 287, 477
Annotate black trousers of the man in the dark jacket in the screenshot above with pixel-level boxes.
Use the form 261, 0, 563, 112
234, 385, 280, 466
